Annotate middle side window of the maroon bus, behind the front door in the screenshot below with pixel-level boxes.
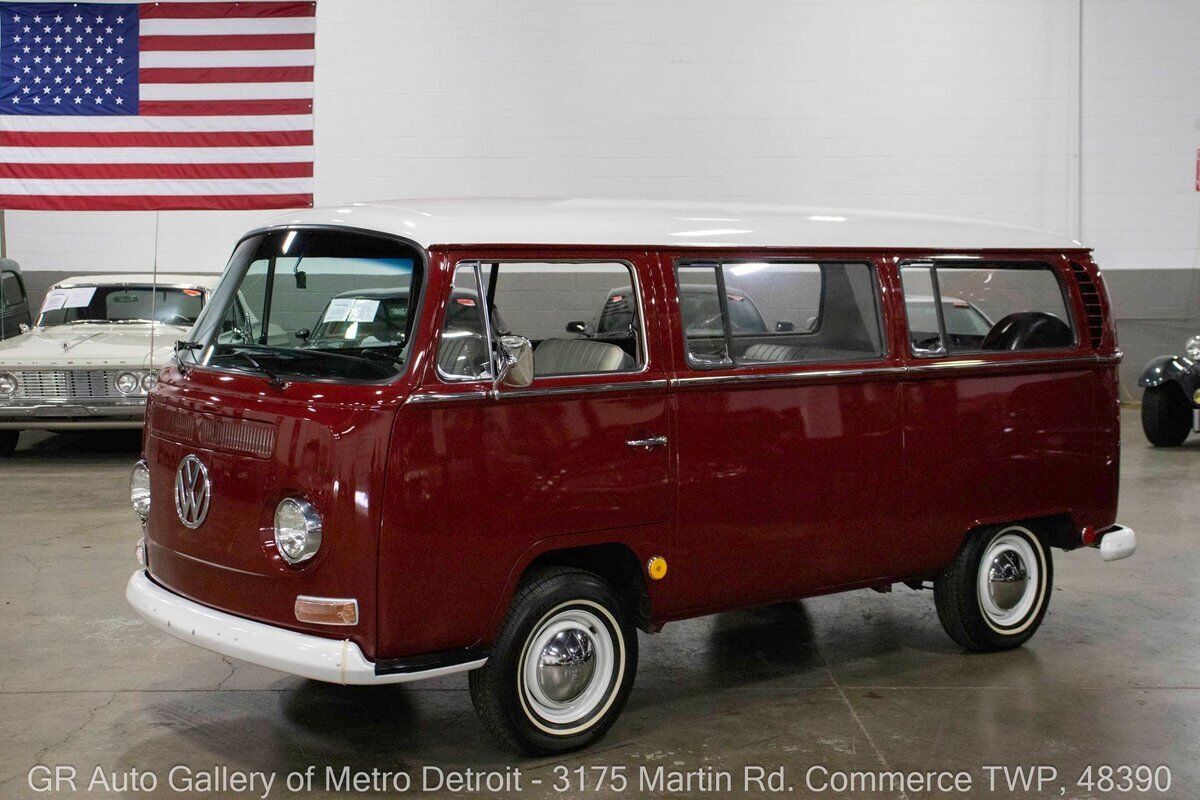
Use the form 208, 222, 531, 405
678, 261, 883, 367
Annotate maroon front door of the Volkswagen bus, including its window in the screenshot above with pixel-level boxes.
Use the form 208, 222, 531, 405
379, 249, 673, 654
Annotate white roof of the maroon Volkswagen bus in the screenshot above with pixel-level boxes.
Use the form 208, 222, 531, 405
266, 199, 1082, 251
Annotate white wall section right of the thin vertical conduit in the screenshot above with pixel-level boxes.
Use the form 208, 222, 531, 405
1082, 0, 1200, 272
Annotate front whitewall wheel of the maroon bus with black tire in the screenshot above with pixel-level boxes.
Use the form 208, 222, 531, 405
468, 567, 637, 756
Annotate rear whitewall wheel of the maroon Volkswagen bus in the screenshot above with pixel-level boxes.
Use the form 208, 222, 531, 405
934, 525, 1054, 651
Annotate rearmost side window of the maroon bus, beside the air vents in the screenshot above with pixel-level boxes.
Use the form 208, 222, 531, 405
900, 261, 1075, 356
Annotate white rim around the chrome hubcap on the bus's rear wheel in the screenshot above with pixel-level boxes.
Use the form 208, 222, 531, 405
976, 525, 1045, 636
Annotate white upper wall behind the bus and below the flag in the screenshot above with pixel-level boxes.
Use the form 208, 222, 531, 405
7, 0, 1200, 278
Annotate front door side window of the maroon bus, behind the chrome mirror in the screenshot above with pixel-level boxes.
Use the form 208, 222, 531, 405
438, 261, 646, 378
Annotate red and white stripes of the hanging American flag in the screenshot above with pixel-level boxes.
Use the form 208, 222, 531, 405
0, 0, 316, 211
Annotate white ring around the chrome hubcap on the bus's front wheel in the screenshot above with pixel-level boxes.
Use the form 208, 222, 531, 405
517, 600, 625, 736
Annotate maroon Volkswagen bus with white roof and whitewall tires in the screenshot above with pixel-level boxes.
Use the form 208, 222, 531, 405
127, 200, 1135, 753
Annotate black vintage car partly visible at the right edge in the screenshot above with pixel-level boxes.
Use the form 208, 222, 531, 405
1138, 336, 1200, 447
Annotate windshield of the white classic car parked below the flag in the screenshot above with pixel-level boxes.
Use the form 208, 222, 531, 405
37, 284, 204, 327
